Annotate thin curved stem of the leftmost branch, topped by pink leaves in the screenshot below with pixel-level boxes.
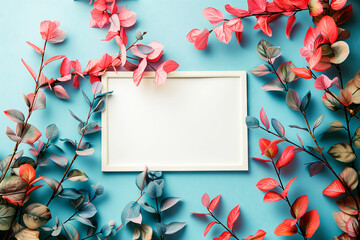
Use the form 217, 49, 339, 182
0, 41, 47, 182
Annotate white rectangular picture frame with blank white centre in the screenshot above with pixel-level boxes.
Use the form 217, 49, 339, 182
101, 71, 248, 172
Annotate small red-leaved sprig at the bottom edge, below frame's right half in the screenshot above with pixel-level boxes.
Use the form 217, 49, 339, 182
191, 193, 266, 240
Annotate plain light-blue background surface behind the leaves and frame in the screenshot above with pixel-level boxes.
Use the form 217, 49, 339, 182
0, 0, 360, 239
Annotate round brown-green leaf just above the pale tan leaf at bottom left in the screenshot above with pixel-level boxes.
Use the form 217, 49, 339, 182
23, 203, 51, 229
